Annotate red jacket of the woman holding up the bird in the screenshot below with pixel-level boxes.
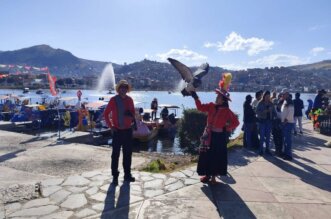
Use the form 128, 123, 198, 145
195, 99, 240, 132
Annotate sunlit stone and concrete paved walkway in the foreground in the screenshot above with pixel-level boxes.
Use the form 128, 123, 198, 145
0, 120, 331, 219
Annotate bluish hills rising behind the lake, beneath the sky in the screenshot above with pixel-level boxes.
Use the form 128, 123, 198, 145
0, 45, 331, 91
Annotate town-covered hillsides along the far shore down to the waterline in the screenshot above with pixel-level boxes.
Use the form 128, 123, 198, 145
0, 45, 331, 93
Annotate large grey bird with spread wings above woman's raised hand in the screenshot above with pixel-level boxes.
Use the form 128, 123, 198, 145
168, 58, 209, 96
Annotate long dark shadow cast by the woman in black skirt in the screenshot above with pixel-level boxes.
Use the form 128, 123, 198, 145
201, 183, 256, 219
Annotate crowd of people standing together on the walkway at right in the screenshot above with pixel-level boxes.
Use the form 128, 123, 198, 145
242, 89, 329, 160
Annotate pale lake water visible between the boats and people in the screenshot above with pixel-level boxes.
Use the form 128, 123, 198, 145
0, 89, 315, 153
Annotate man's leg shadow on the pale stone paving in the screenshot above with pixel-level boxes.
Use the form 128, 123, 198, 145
100, 182, 130, 219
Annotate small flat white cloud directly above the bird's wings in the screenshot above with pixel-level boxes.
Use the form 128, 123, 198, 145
156, 49, 208, 64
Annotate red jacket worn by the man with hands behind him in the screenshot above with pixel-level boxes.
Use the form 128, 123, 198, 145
104, 95, 135, 129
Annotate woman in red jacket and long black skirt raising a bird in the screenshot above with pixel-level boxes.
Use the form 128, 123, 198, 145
192, 74, 239, 184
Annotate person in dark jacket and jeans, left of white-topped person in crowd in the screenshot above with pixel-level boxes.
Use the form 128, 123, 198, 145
256, 91, 276, 155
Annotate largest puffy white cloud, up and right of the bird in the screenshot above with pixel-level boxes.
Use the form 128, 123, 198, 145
204, 32, 274, 56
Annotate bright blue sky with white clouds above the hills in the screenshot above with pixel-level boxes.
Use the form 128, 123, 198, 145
0, 0, 331, 69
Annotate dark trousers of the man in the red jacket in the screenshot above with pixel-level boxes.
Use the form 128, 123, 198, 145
111, 129, 133, 177
